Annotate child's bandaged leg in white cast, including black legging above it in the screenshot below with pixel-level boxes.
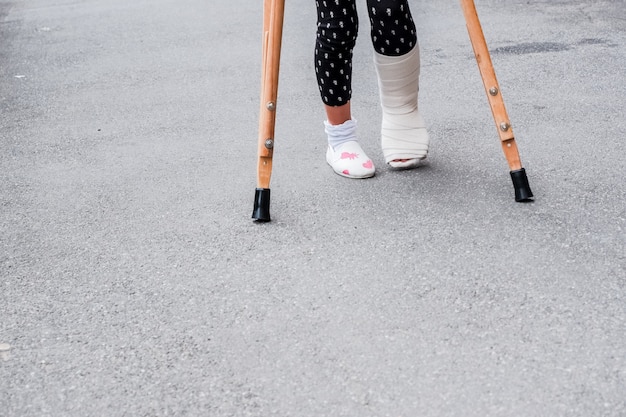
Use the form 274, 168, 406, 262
368, 0, 429, 168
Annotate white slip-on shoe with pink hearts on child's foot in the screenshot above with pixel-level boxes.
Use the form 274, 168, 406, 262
326, 141, 376, 178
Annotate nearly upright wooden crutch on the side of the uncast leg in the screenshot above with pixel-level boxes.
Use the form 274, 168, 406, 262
252, 0, 285, 222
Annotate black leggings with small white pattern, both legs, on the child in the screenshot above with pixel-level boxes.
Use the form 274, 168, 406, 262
315, 0, 417, 106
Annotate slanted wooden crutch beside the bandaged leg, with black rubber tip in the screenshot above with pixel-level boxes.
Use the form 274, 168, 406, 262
461, 0, 533, 202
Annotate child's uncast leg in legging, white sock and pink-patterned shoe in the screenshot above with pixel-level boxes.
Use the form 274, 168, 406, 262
315, 0, 374, 178
